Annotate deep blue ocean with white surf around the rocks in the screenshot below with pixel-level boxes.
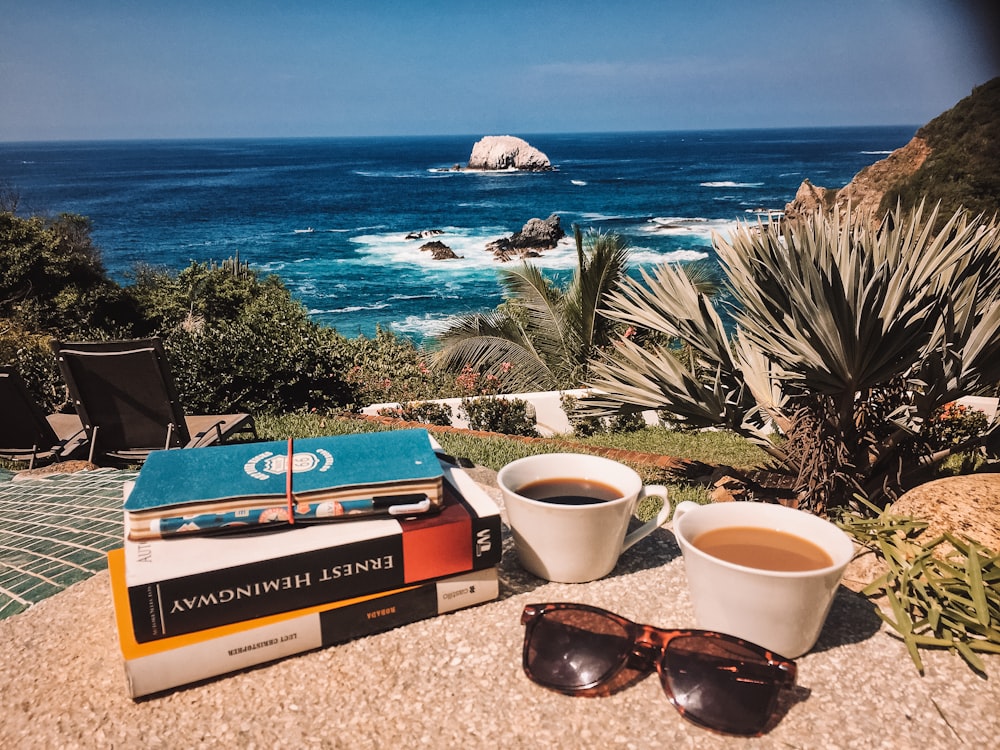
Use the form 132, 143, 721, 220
0, 126, 916, 341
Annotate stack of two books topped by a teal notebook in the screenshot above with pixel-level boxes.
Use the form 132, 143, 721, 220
108, 429, 501, 698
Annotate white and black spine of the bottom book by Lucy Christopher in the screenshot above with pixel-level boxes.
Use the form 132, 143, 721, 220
125, 567, 499, 698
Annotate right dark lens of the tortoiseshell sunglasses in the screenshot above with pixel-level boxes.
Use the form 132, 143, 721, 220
660, 635, 785, 735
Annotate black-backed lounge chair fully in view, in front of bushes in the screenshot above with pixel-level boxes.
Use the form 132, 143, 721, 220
52, 338, 257, 463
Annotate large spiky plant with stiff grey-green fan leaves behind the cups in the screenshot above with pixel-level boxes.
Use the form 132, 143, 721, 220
590, 205, 1000, 512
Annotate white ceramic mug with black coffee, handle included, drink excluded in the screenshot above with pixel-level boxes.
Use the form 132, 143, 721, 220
497, 453, 670, 583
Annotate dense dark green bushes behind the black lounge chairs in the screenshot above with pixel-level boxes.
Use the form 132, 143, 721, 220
0, 209, 452, 413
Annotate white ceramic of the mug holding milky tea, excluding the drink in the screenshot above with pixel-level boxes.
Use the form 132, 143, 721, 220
673, 501, 854, 659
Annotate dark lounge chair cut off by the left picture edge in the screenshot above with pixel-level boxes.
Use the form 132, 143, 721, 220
0, 366, 87, 469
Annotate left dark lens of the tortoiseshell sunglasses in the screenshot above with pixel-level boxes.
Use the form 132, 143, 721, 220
524, 609, 631, 692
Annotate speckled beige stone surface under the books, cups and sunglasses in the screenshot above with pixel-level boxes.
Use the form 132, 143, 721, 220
0, 476, 1000, 750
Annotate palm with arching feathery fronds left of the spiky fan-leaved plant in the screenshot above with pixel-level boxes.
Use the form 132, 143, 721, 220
433, 226, 629, 392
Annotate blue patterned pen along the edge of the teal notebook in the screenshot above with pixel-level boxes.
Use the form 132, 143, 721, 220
135, 493, 431, 539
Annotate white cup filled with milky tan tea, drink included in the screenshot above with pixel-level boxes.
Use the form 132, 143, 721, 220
673, 502, 854, 659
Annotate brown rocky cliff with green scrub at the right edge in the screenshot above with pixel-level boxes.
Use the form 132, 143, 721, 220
785, 78, 1000, 229
